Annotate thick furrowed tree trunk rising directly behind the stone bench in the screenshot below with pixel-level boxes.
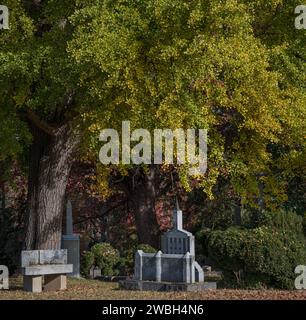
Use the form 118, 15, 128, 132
25, 125, 79, 250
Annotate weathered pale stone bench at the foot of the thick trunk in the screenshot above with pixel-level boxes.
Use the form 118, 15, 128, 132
21, 249, 73, 292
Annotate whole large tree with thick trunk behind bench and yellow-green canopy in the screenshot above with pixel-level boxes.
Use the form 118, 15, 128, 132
0, 0, 305, 249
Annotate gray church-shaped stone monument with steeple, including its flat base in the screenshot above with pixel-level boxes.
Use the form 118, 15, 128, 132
119, 203, 216, 291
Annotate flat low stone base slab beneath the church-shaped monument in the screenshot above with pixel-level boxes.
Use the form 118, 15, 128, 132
119, 279, 217, 292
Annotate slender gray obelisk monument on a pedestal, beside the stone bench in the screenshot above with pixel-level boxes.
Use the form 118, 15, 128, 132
62, 200, 80, 278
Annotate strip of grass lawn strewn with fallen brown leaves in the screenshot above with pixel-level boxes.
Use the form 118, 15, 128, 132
0, 277, 306, 300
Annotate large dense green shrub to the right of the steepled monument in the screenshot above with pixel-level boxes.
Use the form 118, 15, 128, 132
208, 212, 306, 289
